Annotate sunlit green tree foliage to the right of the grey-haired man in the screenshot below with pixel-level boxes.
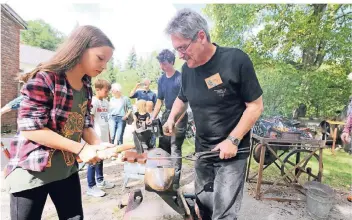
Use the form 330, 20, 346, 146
204, 4, 352, 117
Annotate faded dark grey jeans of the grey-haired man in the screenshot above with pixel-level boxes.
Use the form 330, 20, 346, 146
195, 158, 247, 220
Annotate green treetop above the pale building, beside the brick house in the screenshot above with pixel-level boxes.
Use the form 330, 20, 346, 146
21, 20, 65, 51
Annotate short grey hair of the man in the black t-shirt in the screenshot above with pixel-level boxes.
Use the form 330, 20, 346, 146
165, 8, 210, 42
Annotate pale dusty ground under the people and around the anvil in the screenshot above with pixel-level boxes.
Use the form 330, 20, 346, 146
0, 131, 352, 220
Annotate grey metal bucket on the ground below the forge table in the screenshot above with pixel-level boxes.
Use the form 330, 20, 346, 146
305, 181, 334, 219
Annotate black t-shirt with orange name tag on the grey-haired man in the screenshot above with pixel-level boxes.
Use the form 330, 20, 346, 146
178, 44, 263, 158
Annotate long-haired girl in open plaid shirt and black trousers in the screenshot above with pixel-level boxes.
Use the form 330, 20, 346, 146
5, 26, 114, 220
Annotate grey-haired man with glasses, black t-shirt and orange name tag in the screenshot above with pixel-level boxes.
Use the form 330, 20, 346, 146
164, 9, 263, 220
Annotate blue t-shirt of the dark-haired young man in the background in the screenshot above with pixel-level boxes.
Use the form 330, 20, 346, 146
158, 70, 181, 110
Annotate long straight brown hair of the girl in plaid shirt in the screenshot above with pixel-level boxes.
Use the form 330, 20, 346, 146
18, 25, 115, 82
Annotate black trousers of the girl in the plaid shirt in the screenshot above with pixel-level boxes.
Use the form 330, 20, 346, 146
10, 173, 83, 220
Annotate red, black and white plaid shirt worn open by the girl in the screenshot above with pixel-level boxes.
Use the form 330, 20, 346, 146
4, 72, 93, 177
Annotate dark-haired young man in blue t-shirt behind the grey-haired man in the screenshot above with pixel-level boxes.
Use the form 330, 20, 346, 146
152, 49, 188, 190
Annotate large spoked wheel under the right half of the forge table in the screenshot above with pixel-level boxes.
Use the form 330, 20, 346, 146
281, 149, 319, 183
